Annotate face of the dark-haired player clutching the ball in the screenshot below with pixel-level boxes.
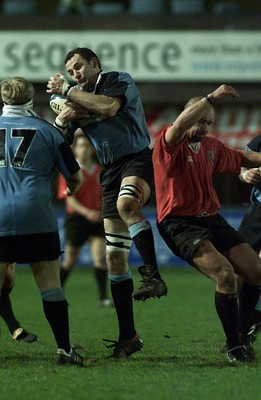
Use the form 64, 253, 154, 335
66, 54, 100, 87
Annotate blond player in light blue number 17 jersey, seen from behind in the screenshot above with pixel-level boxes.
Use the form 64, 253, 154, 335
0, 78, 83, 366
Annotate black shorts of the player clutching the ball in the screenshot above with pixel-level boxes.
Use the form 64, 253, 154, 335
100, 148, 154, 218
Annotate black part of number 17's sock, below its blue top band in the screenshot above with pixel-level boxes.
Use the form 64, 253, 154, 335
43, 300, 71, 353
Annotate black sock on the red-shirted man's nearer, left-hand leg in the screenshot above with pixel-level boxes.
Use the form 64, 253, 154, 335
215, 291, 240, 349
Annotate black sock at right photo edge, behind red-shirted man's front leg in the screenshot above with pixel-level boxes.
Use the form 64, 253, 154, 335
239, 281, 260, 335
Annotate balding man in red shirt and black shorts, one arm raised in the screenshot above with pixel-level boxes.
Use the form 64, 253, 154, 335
153, 85, 261, 362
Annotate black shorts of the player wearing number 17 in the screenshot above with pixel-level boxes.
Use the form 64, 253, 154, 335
0, 232, 61, 264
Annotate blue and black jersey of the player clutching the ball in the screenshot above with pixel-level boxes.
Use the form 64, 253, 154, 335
68, 71, 150, 165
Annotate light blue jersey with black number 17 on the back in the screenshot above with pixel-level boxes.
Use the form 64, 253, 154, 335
0, 112, 79, 236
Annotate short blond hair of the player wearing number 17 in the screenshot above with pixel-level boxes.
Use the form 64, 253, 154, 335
0, 77, 34, 104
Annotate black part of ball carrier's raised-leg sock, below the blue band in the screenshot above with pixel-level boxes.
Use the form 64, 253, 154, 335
133, 228, 162, 279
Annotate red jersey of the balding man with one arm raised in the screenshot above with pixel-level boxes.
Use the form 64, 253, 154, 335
153, 126, 242, 223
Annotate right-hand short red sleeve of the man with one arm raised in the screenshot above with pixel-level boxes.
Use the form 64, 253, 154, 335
213, 140, 243, 175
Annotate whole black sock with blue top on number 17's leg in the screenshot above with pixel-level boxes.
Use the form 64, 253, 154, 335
41, 288, 71, 353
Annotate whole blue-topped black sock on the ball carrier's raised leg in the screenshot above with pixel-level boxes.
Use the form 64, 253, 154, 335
129, 219, 162, 280
